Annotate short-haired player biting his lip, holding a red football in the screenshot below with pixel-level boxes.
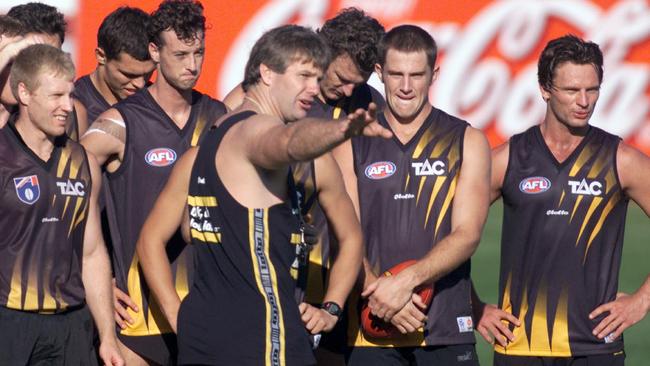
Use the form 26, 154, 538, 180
335, 25, 490, 365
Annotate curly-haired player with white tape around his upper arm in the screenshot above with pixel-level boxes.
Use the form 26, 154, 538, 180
82, 0, 226, 365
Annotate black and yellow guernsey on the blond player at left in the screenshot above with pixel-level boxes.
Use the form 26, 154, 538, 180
0, 123, 91, 314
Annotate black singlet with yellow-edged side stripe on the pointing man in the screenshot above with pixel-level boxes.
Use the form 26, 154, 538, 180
178, 112, 315, 366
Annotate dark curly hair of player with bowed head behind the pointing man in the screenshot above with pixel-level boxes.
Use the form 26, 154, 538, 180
317, 8, 385, 76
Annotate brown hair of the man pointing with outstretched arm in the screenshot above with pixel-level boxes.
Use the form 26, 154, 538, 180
242, 25, 330, 91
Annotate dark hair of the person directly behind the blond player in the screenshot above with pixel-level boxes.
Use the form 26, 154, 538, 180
7, 3, 67, 43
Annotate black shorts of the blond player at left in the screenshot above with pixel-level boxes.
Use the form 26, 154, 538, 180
0, 305, 97, 366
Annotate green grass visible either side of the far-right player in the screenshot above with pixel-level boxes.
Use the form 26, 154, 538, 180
472, 202, 650, 366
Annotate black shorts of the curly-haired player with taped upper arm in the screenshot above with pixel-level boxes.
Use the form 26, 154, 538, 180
117, 333, 178, 366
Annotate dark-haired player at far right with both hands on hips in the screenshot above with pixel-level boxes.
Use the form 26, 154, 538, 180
470, 35, 650, 365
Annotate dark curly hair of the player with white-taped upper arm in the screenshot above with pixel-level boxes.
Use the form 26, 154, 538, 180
149, 0, 205, 47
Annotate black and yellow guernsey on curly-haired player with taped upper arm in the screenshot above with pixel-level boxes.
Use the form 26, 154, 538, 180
106, 89, 226, 336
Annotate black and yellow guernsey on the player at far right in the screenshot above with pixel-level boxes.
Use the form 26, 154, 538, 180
495, 126, 628, 357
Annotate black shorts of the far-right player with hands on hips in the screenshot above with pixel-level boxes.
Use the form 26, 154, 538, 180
494, 351, 625, 366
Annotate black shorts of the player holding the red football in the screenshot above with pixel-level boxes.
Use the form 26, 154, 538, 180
346, 344, 479, 366
